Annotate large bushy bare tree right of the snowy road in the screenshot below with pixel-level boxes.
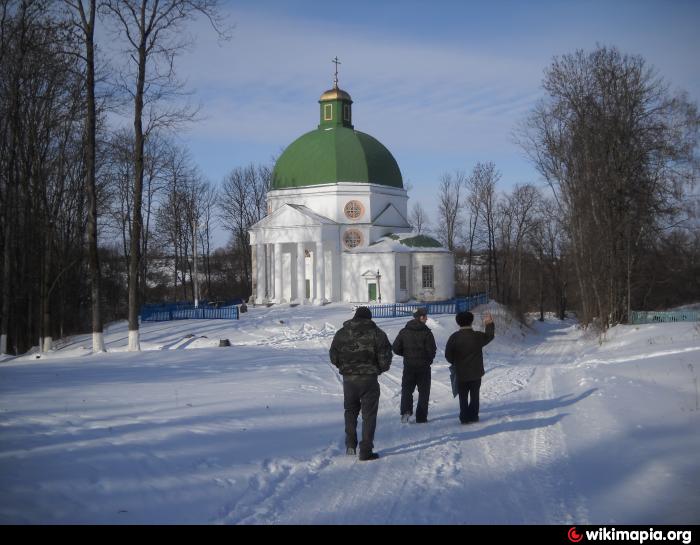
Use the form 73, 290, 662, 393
520, 47, 700, 330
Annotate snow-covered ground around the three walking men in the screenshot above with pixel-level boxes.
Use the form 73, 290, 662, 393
0, 304, 700, 524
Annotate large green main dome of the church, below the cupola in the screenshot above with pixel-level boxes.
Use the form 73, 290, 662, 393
272, 126, 403, 189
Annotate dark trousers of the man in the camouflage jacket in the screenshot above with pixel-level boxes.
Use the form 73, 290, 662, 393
343, 375, 379, 455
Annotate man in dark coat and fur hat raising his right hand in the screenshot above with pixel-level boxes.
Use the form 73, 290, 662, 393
445, 312, 495, 424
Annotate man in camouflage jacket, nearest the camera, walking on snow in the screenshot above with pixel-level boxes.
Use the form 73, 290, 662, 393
329, 307, 392, 461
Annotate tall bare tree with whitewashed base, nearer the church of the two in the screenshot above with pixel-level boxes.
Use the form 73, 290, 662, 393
104, 0, 228, 350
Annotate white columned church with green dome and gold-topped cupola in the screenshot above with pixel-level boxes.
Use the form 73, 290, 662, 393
249, 69, 455, 305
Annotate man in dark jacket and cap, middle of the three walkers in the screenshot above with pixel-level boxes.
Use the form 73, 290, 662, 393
392, 308, 437, 424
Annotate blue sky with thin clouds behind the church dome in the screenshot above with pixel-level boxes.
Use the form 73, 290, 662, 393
134, 0, 700, 239
